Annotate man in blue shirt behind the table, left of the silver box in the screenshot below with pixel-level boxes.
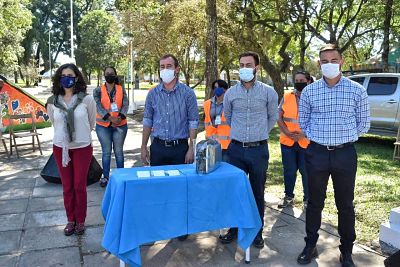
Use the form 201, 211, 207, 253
141, 54, 199, 166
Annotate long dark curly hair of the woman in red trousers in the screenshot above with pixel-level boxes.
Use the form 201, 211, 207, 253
51, 63, 87, 95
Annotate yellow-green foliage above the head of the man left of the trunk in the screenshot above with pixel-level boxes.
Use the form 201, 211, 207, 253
117, 0, 206, 83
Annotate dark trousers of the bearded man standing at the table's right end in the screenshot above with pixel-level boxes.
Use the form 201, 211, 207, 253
228, 143, 269, 234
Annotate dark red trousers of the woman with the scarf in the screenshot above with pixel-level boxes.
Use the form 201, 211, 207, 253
53, 145, 93, 223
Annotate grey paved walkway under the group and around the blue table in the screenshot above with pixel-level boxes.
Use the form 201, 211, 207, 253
0, 112, 384, 267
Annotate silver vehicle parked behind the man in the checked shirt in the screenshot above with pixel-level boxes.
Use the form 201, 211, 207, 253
349, 73, 400, 136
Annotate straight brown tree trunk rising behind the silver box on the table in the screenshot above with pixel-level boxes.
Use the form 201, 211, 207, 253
205, 0, 218, 100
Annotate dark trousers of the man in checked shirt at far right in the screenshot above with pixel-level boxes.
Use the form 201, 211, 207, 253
305, 142, 357, 254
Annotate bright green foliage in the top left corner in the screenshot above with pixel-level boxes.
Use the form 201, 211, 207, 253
0, 0, 32, 71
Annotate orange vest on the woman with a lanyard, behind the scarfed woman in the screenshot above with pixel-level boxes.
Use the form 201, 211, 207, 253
96, 84, 126, 127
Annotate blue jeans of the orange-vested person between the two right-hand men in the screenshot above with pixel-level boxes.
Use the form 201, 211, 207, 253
281, 142, 308, 201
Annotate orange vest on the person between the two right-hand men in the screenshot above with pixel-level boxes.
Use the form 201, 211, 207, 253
279, 93, 310, 148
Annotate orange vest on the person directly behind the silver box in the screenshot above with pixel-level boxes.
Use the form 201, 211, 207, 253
203, 99, 231, 149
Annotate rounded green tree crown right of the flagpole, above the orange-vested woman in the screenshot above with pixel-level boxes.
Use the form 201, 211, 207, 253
76, 10, 123, 75
